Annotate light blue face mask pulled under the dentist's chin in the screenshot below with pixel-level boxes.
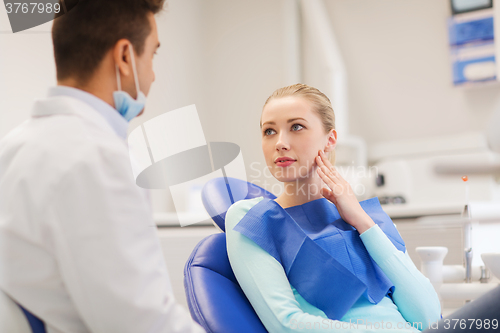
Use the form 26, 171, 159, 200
113, 45, 146, 121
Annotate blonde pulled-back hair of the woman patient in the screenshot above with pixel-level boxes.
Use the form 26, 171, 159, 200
260, 83, 335, 165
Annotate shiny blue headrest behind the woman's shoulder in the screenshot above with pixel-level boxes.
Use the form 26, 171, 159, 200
201, 177, 276, 231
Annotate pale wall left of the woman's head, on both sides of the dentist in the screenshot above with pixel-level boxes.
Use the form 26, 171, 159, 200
0, 0, 285, 211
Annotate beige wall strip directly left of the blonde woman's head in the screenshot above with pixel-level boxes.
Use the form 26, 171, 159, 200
198, 0, 287, 195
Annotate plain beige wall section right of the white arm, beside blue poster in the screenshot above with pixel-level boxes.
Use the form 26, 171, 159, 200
326, 0, 500, 144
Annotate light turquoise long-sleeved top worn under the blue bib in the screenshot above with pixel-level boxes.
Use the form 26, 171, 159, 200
226, 197, 441, 333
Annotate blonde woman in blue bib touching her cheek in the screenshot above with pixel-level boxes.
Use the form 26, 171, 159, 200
226, 84, 441, 332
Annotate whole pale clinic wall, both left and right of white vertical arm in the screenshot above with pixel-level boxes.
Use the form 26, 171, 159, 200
0, 0, 500, 205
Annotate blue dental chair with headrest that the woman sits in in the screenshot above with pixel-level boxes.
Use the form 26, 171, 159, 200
184, 177, 276, 333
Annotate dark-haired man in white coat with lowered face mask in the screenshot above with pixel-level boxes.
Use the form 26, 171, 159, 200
0, 0, 203, 333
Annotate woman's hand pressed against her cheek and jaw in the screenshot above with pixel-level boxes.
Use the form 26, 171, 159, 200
316, 150, 375, 234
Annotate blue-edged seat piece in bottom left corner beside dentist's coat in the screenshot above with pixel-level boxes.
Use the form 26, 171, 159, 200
0, 290, 46, 333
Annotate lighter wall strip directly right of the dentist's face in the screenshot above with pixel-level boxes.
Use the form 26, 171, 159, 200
129, 0, 206, 212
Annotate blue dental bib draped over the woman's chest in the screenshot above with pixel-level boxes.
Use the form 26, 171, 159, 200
234, 198, 405, 320
